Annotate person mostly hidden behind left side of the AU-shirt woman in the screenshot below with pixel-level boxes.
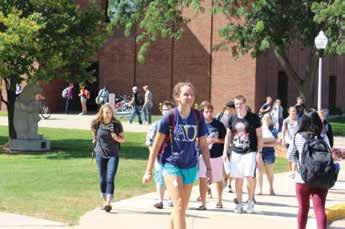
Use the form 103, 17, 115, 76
145, 101, 174, 209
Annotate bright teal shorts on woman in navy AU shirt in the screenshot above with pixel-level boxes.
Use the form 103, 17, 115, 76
163, 163, 199, 185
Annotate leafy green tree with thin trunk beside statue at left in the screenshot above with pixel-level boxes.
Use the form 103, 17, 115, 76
0, 0, 107, 139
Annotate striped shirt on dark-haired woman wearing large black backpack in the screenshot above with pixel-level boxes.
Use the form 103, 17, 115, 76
288, 133, 329, 184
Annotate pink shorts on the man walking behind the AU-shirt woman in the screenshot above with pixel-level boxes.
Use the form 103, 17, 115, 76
199, 156, 224, 182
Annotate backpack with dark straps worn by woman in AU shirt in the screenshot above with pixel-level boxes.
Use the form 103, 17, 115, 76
158, 109, 201, 162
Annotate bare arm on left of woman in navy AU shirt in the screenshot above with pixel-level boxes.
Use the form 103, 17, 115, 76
143, 132, 165, 184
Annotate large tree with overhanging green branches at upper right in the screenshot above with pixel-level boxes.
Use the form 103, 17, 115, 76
111, 0, 345, 104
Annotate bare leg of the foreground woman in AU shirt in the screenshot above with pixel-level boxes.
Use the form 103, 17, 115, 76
165, 175, 187, 229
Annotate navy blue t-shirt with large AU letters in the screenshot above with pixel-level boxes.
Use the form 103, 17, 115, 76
158, 108, 207, 169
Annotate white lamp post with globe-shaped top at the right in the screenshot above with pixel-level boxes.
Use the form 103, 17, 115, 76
315, 30, 328, 111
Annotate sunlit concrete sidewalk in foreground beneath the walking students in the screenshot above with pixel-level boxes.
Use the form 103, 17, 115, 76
75, 162, 345, 229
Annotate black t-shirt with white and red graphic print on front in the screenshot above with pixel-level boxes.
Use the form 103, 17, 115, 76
229, 112, 261, 154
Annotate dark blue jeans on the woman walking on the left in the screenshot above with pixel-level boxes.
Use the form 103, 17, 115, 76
96, 153, 119, 198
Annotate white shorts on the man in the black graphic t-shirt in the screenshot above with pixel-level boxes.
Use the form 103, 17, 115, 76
230, 152, 256, 178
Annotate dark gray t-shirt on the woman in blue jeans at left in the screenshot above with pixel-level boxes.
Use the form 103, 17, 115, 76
93, 120, 123, 157
